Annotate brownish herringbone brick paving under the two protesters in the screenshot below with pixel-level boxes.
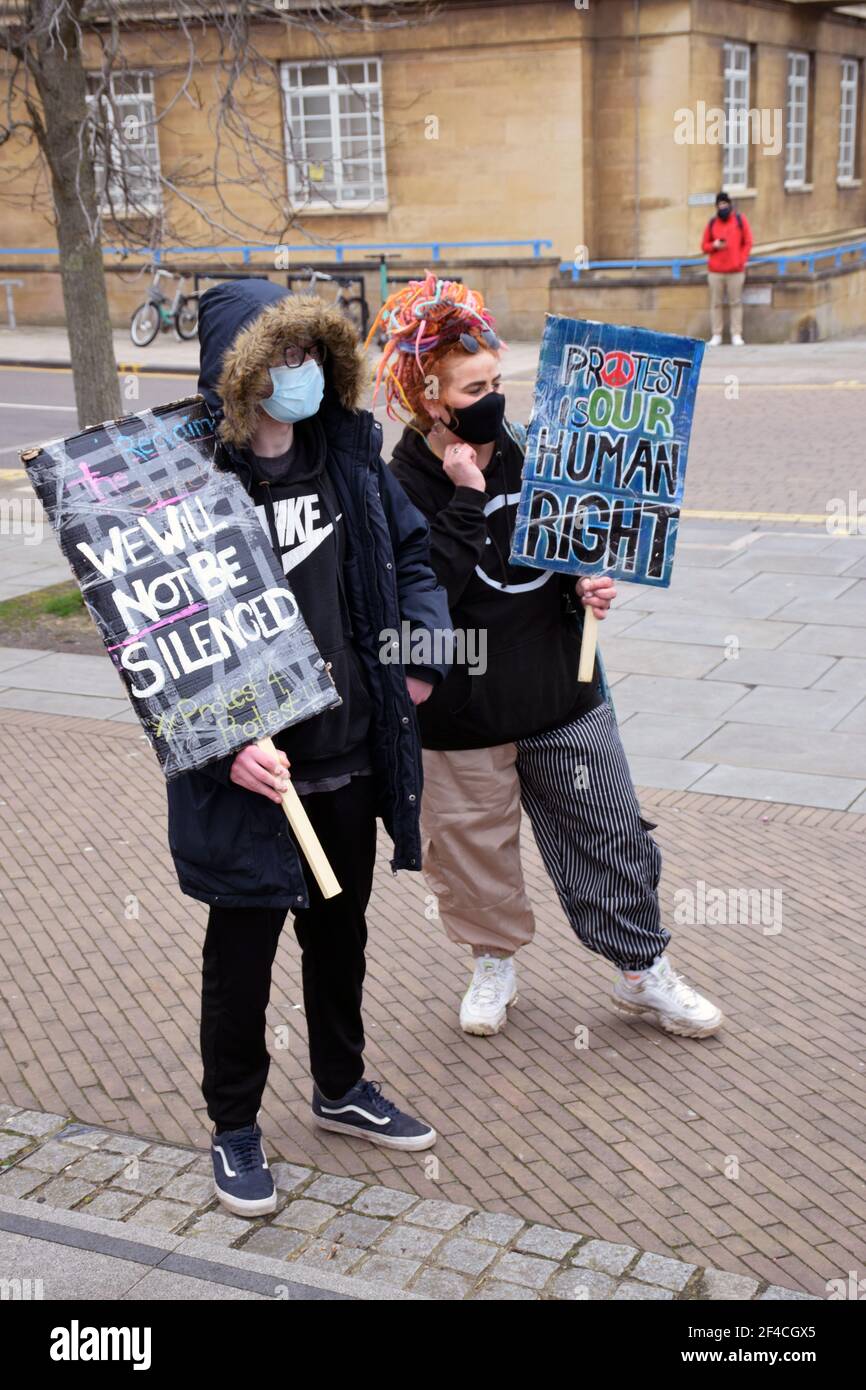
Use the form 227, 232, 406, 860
0, 710, 866, 1297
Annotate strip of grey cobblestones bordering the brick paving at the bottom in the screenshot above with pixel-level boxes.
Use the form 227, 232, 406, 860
0, 1105, 813, 1301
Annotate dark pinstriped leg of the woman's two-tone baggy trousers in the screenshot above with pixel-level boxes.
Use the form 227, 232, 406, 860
517, 702, 670, 970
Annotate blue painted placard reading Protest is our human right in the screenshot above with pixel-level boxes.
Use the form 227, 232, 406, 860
512, 314, 703, 588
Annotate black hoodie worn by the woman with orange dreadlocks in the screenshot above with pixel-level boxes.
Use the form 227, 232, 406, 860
391, 424, 602, 749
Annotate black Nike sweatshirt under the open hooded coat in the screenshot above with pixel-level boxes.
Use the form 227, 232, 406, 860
246, 425, 373, 785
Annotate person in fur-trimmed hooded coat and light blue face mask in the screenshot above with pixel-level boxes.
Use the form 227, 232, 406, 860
168, 279, 449, 1216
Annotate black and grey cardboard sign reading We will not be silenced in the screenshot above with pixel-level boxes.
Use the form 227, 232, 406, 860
21, 396, 339, 777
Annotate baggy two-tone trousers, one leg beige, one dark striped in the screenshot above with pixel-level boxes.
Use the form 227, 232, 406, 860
421, 702, 670, 970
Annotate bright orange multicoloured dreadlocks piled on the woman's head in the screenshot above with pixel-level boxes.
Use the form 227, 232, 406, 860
367, 271, 506, 428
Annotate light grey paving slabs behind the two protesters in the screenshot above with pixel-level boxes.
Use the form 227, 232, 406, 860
0, 521, 866, 812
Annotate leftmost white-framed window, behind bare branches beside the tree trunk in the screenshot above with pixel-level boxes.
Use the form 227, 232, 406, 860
88, 72, 161, 217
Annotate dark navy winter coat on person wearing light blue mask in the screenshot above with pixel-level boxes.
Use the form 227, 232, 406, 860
168, 282, 450, 909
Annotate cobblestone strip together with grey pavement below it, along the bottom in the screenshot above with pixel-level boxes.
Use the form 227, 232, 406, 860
0, 1105, 813, 1302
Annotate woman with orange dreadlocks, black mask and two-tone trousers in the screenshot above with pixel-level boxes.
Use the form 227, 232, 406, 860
374, 274, 721, 1037
